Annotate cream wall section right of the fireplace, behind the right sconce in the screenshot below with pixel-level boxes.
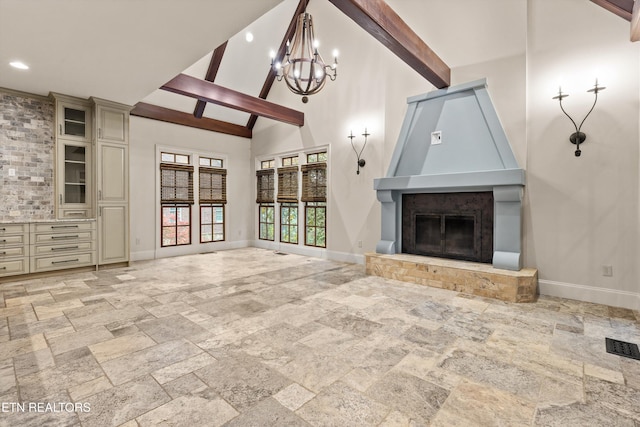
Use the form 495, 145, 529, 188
525, 0, 640, 308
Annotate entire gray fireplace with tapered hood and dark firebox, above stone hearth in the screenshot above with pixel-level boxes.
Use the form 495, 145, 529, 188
374, 79, 525, 271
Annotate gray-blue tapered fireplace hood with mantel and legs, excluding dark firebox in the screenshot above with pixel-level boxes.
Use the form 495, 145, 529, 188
374, 79, 525, 270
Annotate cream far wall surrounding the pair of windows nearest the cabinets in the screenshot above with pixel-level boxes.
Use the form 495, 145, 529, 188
130, 116, 255, 261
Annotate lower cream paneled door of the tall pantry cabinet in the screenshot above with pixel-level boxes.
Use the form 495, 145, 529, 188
98, 205, 129, 264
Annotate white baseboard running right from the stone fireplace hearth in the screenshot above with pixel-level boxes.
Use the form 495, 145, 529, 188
538, 279, 640, 310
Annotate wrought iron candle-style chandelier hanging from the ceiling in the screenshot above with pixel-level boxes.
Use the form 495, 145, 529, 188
271, 11, 338, 103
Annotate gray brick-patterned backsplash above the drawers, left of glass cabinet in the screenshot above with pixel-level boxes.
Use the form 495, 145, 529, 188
0, 91, 55, 221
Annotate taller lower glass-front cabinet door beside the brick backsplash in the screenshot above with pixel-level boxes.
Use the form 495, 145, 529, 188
57, 139, 92, 218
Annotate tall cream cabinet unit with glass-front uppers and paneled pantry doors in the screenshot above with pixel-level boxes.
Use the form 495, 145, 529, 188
50, 93, 131, 268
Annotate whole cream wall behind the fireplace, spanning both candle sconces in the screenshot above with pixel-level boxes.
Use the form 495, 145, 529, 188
252, 0, 640, 308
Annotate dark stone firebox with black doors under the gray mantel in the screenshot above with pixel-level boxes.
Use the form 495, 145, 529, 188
402, 192, 493, 263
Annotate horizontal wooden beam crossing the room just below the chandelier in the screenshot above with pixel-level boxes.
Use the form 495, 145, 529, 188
160, 74, 304, 126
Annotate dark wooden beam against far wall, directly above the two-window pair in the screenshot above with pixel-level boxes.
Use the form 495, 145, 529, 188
131, 102, 252, 138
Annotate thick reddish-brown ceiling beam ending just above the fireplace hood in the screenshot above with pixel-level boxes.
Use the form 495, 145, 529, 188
329, 0, 451, 88
